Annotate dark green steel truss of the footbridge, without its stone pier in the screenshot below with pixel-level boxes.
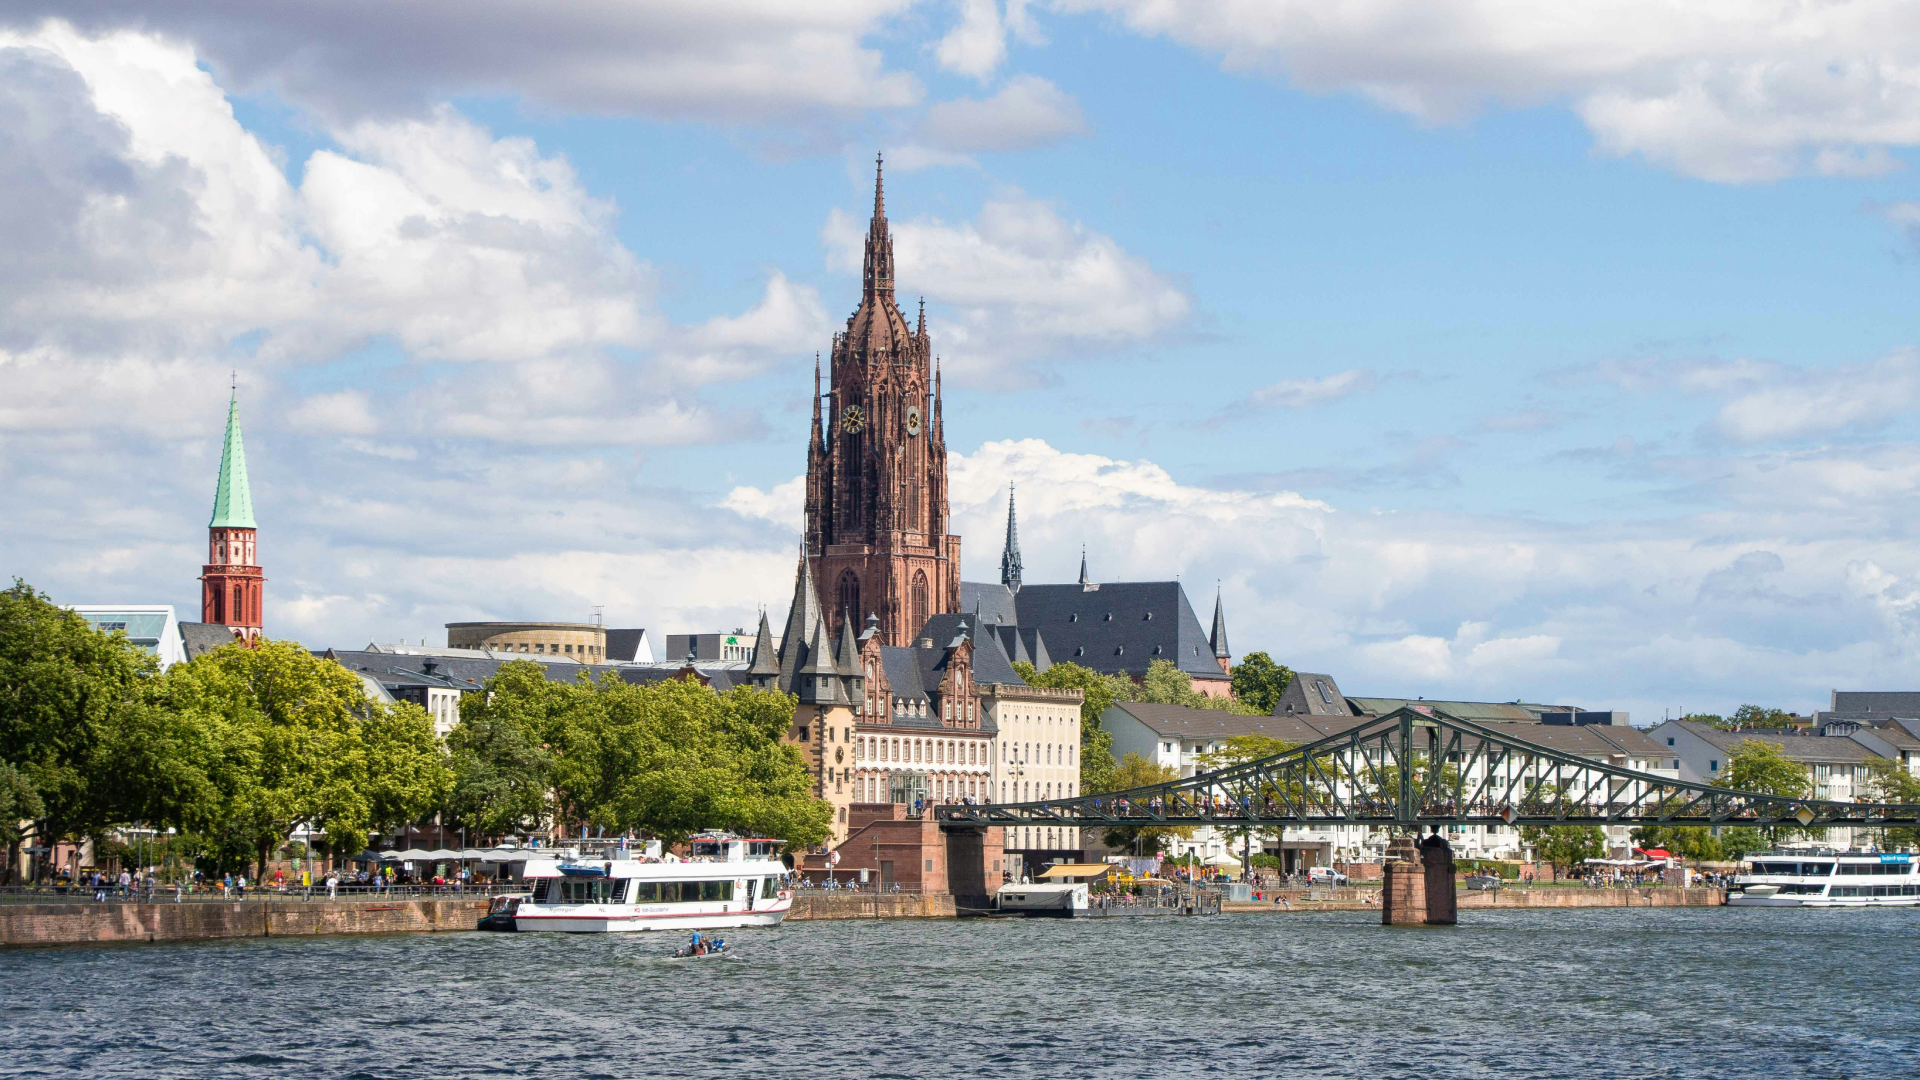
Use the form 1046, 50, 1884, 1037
935, 705, 1920, 828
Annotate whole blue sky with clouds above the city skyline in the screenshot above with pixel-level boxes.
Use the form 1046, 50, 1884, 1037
0, 0, 1920, 723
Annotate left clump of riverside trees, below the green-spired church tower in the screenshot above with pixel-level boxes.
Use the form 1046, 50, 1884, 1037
0, 580, 449, 872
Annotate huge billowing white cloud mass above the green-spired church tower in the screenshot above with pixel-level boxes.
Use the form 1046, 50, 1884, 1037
0, 23, 828, 459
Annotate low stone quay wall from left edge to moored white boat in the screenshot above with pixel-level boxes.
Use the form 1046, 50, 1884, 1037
0, 897, 488, 945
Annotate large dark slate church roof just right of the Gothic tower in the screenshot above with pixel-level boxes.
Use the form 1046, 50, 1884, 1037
960, 580, 1227, 680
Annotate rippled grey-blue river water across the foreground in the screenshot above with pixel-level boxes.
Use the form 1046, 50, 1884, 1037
0, 909, 1920, 1080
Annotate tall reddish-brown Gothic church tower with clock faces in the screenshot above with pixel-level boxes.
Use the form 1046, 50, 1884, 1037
806, 161, 960, 646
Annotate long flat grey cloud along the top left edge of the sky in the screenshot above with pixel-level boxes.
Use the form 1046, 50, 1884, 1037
10, 0, 920, 121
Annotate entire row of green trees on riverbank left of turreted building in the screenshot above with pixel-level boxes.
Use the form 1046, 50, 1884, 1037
0, 580, 829, 874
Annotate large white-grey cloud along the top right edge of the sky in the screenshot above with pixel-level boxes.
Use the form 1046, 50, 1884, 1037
1058, 0, 1920, 181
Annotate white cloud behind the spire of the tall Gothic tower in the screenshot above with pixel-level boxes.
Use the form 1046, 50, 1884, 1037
822, 198, 1192, 380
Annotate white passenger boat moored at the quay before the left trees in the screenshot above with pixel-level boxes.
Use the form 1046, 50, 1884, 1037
513, 834, 793, 934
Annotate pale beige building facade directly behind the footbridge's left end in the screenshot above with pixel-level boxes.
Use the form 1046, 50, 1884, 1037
979, 682, 1081, 851
